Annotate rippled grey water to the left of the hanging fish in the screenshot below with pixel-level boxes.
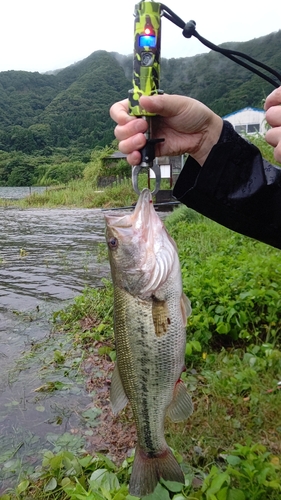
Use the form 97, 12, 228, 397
0, 204, 109, 492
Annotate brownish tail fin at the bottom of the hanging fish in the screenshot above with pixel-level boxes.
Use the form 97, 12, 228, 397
129, 445, 184, 497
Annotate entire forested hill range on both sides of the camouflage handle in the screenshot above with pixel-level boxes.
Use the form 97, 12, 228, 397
0, 31, 281, 154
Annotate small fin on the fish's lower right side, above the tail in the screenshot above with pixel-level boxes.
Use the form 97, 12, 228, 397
166, 380, 193, 422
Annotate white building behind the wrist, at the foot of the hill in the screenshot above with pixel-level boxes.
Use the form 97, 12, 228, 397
223, 108, 266, 135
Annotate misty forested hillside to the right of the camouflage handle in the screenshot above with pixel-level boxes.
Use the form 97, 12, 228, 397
113, 30, 281, 116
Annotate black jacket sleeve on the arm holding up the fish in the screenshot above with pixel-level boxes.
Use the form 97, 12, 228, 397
173, 121, 281, 249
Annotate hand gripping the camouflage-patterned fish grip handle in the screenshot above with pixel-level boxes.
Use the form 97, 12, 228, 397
110, 94, 223, 165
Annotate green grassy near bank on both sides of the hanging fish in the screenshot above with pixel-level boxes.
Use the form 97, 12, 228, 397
0, 208, 281, 500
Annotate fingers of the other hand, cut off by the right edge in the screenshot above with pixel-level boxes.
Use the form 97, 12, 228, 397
264, 87, 281, 163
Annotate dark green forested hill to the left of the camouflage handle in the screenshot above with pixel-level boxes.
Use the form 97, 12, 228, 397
0, 51, 130, 153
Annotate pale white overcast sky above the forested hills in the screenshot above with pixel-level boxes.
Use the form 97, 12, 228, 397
0, 0, 281, 72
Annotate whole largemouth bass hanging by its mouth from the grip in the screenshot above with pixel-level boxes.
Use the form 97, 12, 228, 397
105, 189, 193, 496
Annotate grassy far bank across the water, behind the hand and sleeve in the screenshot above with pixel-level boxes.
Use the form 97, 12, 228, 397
0, 135, 276, 208
